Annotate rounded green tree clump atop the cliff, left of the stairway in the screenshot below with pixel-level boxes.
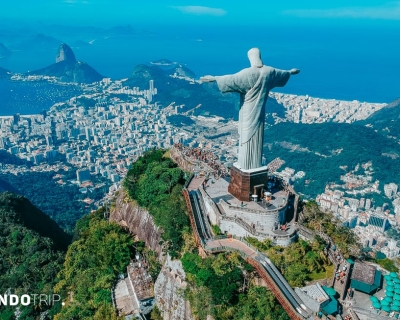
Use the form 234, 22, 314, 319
124, 149, 189, 258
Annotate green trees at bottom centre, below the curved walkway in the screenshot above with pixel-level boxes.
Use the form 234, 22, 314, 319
181, 252, 289, 320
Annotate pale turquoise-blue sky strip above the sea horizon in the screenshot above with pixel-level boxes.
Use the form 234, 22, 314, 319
0, 0, 400, 25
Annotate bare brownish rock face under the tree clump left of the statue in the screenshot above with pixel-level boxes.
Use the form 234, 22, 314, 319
110, 190, 165, 261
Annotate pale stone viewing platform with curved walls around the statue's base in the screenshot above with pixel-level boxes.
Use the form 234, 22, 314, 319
187, 170, 297, 246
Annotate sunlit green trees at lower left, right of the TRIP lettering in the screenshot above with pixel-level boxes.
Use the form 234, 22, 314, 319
54, 209, 131, 320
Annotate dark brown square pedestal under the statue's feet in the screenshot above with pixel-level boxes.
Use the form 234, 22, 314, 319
228, 163, 268, 201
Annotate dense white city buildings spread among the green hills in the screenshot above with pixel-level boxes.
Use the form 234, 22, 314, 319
0, 75, 400, 258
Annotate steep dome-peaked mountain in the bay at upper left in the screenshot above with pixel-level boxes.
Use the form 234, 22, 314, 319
28, 43, 103, 83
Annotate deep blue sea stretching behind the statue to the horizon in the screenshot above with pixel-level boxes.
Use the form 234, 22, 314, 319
0, 25, 400, 113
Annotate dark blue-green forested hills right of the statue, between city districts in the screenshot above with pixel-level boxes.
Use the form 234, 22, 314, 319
264, 122, 400, 205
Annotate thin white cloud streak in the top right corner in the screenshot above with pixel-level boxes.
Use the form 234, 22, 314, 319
283, 1, 400, 20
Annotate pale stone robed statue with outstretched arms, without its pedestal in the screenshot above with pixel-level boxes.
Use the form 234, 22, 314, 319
200, 48, 300, 170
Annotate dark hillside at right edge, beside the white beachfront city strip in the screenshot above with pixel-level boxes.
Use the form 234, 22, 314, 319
357, 98, 400, 141
